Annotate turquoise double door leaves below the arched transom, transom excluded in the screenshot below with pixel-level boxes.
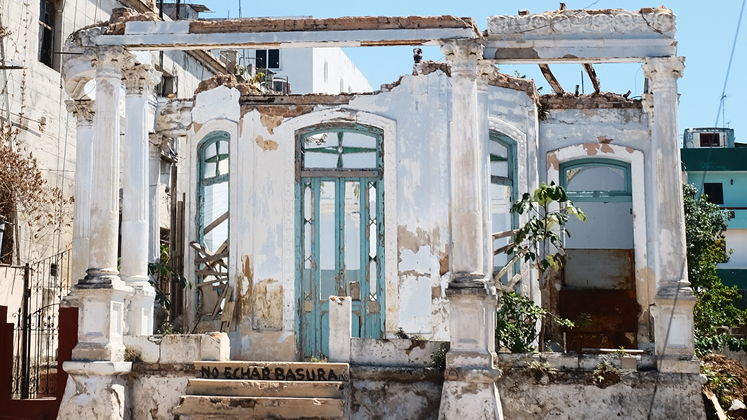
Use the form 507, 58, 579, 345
296, 177, 384, 359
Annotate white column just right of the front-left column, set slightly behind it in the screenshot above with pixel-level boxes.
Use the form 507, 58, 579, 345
120, 63, 161, 335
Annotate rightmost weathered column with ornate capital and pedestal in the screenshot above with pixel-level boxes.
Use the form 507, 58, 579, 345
643, 57, 698, 373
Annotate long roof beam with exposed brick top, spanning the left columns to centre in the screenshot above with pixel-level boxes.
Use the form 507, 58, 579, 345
93, 16, 480, 50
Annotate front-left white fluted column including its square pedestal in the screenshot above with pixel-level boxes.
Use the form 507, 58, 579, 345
73, 47, 132, 362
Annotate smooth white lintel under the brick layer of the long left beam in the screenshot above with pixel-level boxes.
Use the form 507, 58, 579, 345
94, 27, 477, 50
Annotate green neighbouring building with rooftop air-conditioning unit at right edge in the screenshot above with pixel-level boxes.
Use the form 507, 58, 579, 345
681, 128, 747, 308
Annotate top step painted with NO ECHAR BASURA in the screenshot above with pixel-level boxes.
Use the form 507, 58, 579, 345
194, 361, 350, 382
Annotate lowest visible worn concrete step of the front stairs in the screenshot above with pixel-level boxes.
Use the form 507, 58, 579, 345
174, 395, 344, 420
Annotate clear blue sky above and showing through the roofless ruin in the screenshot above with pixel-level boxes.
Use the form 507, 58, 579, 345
196, 0, 747, 143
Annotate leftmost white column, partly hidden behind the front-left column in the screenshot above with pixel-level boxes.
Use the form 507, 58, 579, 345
65, 100, 94, 285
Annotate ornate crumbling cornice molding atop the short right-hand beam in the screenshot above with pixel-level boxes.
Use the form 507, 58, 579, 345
488, 6, 676, 38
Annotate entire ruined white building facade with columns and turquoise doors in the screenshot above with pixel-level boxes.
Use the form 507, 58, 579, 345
52, 7, 702, 419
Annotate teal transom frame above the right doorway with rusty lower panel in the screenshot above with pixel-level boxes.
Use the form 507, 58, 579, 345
559, 158, 633, 202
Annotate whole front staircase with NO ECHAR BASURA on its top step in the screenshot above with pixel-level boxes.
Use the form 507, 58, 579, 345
174, 362, 350, 420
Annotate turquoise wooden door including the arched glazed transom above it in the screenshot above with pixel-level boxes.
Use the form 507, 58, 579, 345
296, 128, 384, 358
